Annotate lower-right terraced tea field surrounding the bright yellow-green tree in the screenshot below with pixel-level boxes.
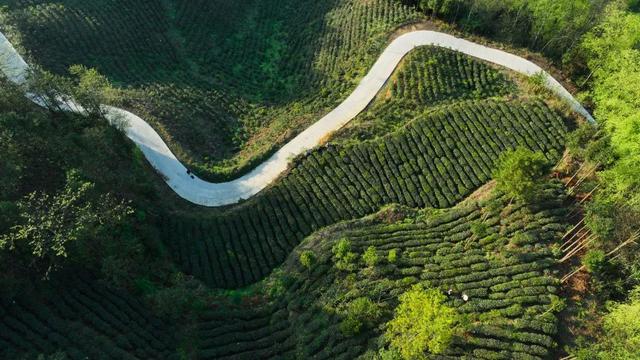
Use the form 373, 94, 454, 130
192, 184, 566, 359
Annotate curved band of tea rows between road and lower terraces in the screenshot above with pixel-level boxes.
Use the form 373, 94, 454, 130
159, 101, 567, 288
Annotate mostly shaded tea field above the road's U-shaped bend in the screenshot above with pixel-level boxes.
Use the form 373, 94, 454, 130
0, 0, 419, 181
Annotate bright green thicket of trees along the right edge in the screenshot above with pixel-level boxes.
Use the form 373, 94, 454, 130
570, 1, 640, 359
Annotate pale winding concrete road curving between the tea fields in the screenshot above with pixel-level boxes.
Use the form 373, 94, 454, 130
0, 31, 595, 207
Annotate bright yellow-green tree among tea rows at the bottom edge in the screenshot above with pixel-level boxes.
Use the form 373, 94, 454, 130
385, 284, 462, 360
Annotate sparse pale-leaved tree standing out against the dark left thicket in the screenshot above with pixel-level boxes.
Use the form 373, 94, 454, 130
0, 170, 132, 277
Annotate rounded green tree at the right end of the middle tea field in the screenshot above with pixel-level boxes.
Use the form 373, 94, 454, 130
493, 147, 550, 201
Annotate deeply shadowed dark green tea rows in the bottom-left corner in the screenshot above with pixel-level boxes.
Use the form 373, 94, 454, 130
0, 273, 176, 359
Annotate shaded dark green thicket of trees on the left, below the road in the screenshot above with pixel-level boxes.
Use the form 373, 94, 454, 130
0, 79, 165, 296
